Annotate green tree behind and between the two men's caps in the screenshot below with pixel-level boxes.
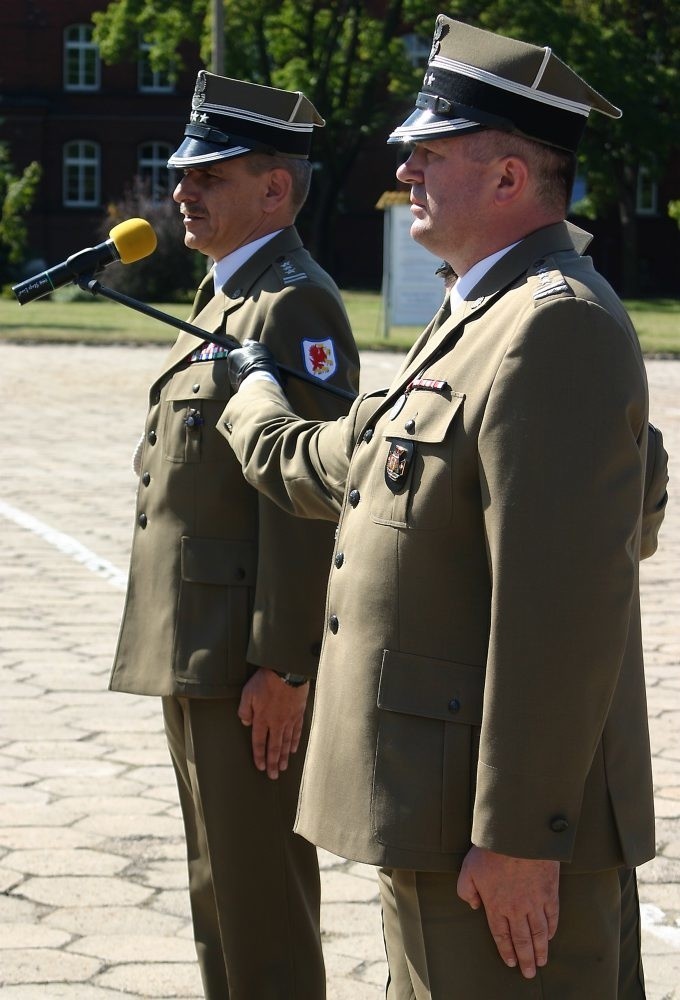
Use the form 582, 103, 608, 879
92, 0, 434, 264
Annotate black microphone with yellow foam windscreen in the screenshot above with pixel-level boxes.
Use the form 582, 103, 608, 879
12, 219, 156, 306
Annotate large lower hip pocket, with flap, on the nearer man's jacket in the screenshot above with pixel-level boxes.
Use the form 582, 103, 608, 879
371, 650, 484, 854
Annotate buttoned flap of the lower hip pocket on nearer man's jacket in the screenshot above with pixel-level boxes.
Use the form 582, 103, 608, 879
378, 649, 484, 726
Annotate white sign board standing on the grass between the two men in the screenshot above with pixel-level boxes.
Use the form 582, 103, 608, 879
383, 204, 444, 336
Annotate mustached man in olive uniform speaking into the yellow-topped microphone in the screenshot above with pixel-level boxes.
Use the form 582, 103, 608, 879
111, 71, 358, 1000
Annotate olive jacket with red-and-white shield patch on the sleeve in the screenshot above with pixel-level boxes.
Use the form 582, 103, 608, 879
111, 228, 358, 697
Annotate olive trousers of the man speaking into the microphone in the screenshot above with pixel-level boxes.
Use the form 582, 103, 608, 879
163, 697, 326, 1000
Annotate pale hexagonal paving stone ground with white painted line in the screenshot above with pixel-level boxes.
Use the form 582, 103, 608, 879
0, 342, 680, 1000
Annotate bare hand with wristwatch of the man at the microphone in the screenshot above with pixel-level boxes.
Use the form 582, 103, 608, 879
238, 667, 309, 778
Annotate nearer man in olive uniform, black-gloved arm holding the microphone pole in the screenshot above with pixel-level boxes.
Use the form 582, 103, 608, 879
222, 15, 662, 1000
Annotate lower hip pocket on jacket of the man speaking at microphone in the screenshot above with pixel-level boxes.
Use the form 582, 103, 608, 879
173, 536, 257, 686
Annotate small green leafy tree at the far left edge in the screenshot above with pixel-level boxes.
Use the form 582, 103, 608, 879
0, 142, 42, 284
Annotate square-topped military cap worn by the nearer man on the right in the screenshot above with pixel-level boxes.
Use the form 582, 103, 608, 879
387, 14, 621, 152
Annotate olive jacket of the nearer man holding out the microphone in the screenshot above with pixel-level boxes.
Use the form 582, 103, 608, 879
224, 224, 654, 871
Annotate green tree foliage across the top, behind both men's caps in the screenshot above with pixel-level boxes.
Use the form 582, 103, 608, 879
93, 0, 680, 291
